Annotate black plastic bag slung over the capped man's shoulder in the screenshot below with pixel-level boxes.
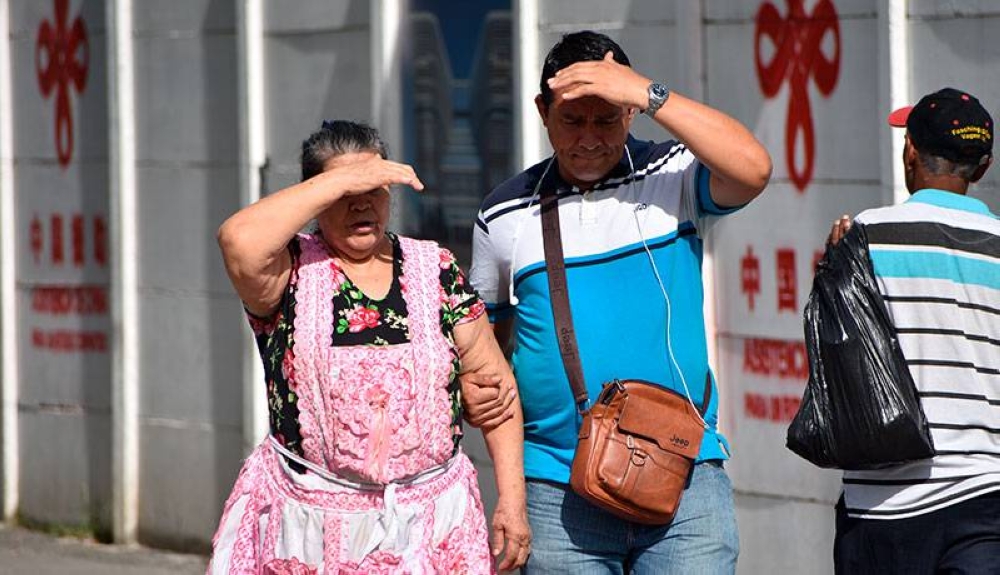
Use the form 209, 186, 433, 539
786, 222, 934, 469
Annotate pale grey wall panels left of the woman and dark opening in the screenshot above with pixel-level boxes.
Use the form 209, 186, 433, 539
2, 0, 382, 549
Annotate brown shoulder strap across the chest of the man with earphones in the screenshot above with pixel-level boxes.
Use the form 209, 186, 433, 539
540, 184, 590, 411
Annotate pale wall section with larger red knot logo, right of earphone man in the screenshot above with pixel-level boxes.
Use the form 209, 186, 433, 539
720, 0, 1000, 573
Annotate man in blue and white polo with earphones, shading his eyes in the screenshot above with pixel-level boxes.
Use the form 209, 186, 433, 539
467, 31, 771, 575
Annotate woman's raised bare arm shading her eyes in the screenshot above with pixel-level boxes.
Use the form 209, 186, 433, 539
218, 153, 423, 317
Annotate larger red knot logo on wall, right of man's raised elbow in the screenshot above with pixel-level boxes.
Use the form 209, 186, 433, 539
754, 0, 840, 192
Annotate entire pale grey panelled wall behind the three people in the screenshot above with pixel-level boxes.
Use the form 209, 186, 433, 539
0, 0, 1000, 574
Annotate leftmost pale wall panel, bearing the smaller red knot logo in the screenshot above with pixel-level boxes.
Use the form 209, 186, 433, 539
2, 1, 111, 529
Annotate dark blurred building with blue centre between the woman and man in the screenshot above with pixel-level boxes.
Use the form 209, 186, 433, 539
408, 6, 513, 256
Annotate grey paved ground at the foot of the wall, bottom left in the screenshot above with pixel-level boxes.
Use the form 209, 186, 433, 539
0, 523, 206, 575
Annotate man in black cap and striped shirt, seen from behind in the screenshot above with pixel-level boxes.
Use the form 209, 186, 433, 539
831, 88, 1000, 575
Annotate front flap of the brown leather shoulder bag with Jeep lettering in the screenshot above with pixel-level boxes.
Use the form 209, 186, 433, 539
618, 385, 705, 459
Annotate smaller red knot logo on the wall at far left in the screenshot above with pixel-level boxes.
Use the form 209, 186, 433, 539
35, 0, 90, 168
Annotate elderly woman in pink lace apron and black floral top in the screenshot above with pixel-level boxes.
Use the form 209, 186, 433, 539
209, 121, 530, 574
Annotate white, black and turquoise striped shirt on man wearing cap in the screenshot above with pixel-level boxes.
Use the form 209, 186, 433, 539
844, 190, 1000, 519
